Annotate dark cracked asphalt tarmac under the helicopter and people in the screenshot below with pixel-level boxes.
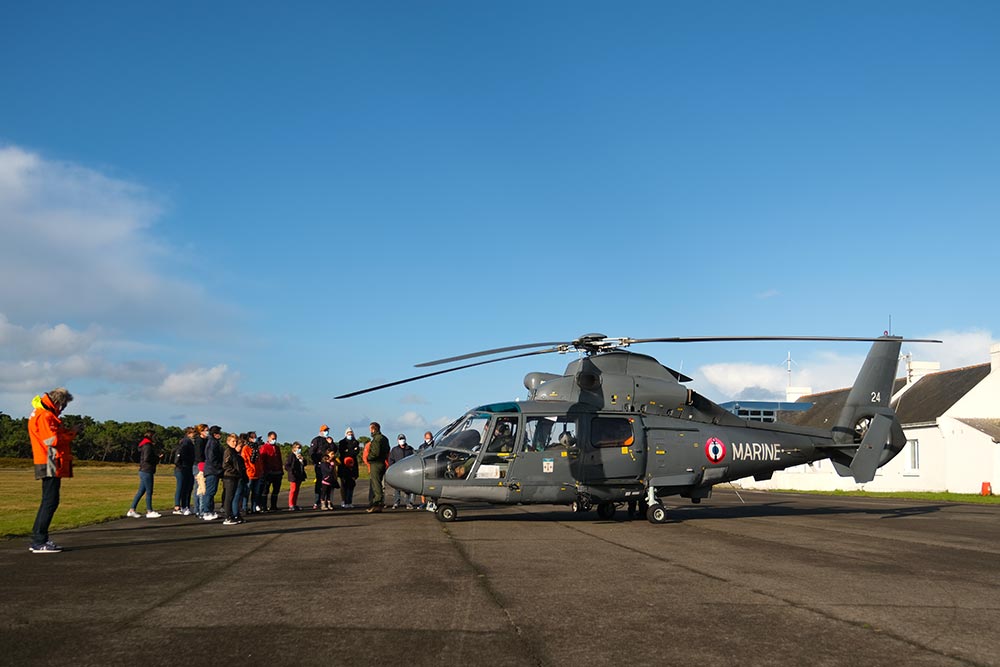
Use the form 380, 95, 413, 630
0, 485, 1000, 667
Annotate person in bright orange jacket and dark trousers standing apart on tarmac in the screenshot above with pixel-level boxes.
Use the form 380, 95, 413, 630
28, 387, 80, 554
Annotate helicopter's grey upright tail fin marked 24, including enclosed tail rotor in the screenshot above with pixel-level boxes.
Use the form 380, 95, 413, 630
831, 336, 906, 483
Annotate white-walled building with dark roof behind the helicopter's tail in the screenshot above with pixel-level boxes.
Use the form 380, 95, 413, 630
737, 345, 1000, 493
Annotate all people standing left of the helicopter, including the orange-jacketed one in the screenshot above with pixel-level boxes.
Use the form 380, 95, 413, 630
28, 387, 442, 553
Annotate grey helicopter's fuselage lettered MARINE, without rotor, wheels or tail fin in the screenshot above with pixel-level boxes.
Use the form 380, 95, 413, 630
386, 400, 832, 504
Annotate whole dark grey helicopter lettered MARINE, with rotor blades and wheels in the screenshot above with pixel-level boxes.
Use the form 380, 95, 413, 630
336, 334, 941, 524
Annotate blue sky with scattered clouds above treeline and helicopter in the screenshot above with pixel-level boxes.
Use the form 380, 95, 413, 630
0, 2, 1000, 440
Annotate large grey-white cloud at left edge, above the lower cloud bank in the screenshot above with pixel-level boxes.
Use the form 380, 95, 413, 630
0, 146, 205, 328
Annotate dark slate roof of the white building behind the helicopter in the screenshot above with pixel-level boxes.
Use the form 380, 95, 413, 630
778, 363, 1000, 428
